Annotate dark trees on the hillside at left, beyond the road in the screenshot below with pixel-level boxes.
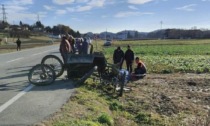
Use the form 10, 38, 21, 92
0, 21, 81, 38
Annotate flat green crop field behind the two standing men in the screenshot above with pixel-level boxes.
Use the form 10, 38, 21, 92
92, 40, 210, 73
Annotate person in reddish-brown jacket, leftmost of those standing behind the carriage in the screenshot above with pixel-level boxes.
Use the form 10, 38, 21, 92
59, 36, 72, 64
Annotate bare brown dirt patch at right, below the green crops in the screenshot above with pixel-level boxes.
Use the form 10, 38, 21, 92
121, 74, 210, 124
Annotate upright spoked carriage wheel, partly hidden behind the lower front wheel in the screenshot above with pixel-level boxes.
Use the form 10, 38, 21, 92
41, 55, 64, 77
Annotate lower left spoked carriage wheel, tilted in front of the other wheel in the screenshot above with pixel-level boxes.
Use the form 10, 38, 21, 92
28, 64, 55, 86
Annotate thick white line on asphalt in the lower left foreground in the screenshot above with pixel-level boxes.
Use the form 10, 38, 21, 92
0, 84, 34, 113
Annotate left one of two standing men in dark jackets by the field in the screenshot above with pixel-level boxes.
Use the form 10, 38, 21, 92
113, 46, 124, 69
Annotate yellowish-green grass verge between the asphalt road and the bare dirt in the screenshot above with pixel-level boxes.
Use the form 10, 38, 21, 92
42, 82, 164, 126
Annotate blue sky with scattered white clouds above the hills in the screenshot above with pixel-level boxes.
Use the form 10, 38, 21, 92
0, 0, 210, 33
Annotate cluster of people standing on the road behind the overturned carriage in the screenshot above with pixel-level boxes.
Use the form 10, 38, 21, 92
59, 35, 91, 64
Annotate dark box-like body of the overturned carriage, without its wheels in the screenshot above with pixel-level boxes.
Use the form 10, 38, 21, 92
65, 52, 106, 79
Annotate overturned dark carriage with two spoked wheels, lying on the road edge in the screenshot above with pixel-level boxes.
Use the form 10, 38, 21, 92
28, 52, 106, 85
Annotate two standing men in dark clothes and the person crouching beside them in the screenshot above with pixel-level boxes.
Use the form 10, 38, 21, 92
113, 45, 147, 79
